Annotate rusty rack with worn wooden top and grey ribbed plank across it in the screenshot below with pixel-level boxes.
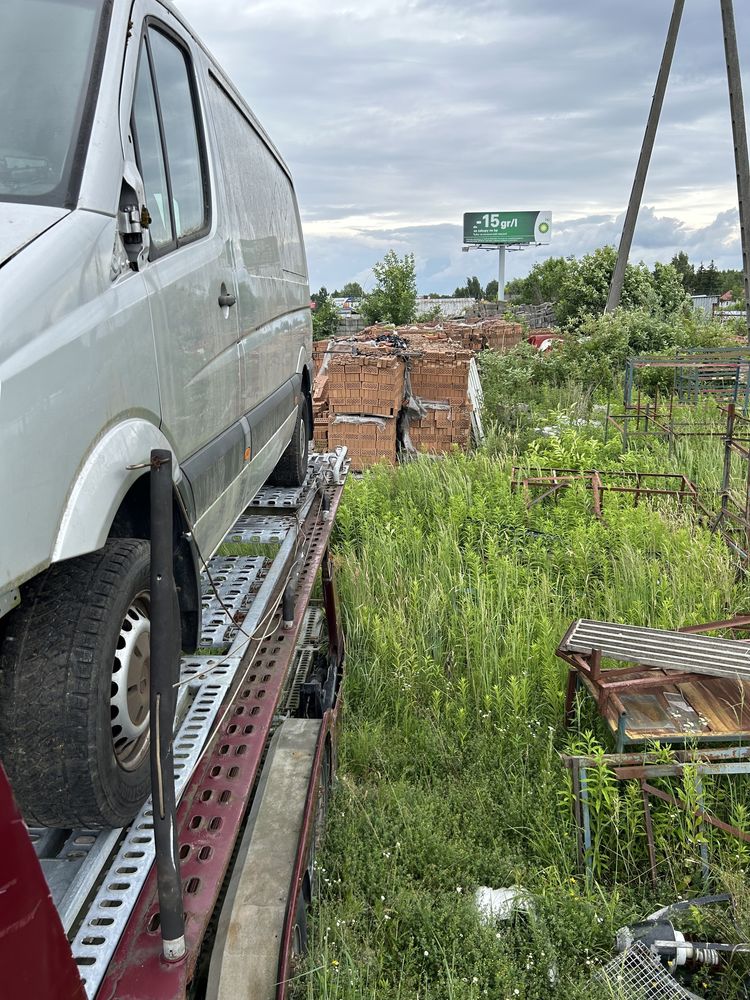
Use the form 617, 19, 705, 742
556, 615, 750, 753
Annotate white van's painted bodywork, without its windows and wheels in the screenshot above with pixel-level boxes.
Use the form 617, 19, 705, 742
0, 0, 312, 616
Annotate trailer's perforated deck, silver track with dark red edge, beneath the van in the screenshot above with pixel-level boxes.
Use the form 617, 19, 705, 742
0, 449, 348, 1000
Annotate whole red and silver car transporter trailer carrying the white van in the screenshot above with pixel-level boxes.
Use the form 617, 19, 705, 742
0, 449, 348, 1000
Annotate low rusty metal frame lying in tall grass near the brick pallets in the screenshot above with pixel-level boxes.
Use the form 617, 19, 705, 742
511, 466, 700, 519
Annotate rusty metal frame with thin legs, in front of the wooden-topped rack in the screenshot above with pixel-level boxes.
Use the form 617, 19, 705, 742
562, 746, 750, 883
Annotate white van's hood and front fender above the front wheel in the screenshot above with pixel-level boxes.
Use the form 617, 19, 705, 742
0, 211, 160, 589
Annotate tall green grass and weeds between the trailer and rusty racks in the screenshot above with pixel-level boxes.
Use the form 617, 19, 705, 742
296, 436, 750, 1000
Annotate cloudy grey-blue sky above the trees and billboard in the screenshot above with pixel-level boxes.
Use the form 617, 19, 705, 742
177, 0, 750, 293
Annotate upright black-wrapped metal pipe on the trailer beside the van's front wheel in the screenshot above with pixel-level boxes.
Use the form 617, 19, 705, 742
150, 449, 185, 962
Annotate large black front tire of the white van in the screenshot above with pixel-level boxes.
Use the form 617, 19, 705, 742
0, 539, 180, 828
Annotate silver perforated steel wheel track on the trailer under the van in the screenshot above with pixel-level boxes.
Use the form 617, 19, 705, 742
29, 453, 352, 998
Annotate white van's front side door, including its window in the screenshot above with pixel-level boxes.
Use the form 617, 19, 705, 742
132, 13, 245, 544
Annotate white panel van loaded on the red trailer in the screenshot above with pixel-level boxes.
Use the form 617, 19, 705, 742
0, 0, 312, 827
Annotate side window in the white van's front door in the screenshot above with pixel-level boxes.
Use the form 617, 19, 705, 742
133, 27, 208, 252
